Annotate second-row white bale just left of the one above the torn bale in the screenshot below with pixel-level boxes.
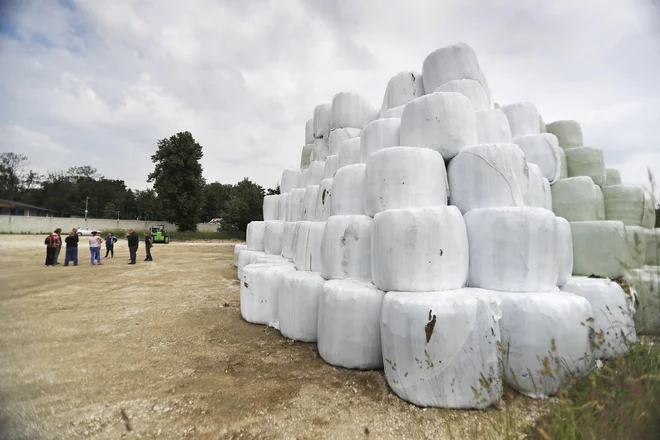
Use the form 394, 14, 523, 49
321, 216, 372, 280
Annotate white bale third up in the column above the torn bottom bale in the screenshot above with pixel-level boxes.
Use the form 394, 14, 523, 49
364, 147, 447, 217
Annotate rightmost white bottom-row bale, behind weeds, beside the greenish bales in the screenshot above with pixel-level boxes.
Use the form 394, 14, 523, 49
561, 277, 637, 359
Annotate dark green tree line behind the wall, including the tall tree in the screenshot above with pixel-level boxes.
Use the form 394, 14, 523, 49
0, 132, 279, 233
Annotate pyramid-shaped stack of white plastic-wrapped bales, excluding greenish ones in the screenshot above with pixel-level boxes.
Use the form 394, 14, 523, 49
239, 44, 648, 408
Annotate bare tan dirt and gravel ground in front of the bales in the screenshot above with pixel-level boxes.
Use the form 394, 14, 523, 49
0, 235, 548, 439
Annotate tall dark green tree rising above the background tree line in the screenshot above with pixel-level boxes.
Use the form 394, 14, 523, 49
148, 131, 204, 231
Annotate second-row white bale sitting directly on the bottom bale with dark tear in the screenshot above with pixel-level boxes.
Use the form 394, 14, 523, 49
371, 206, 469, 292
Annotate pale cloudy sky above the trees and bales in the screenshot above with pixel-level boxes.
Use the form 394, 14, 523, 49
0, 0, 660, 189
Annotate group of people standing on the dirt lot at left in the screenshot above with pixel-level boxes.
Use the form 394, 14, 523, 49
44, 228, 153, 267
